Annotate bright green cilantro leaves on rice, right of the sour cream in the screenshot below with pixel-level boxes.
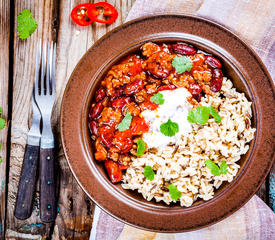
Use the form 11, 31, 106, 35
187, 106, 221, 125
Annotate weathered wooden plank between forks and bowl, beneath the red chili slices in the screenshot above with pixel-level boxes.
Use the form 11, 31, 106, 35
52, 0, 136, 239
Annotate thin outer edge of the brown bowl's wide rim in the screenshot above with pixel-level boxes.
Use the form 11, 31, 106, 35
60, 13, 275, 232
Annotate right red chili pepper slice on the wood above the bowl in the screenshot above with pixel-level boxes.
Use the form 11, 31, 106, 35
88, 2, 118, 24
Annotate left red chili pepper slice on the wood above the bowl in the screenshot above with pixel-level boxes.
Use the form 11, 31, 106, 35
71, 3, 97, 26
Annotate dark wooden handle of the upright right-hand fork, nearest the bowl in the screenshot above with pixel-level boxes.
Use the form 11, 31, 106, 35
40, 148, 56, 222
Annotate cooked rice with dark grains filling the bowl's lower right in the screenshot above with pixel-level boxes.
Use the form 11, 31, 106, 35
122, 78, 256, 207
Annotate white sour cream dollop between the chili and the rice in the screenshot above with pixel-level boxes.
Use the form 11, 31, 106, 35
141, 88, 193, 148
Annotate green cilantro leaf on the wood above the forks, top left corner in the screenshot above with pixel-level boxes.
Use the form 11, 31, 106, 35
17, 9, 37, 39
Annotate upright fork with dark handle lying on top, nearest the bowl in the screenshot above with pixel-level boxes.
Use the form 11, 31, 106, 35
34, 42, 56, 222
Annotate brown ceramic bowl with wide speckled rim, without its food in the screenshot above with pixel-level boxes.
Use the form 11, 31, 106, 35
61, 15, 275, 232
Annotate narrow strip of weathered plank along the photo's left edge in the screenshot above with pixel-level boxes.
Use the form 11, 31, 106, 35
0, 1, 10, 239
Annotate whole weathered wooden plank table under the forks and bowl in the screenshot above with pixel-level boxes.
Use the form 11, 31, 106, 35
0, 0, 274, 239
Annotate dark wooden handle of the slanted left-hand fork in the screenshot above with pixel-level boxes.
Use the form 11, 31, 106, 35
14, 144, 39, 220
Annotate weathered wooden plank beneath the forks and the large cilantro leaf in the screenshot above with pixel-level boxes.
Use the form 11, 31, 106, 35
6, 0, 56, 239
